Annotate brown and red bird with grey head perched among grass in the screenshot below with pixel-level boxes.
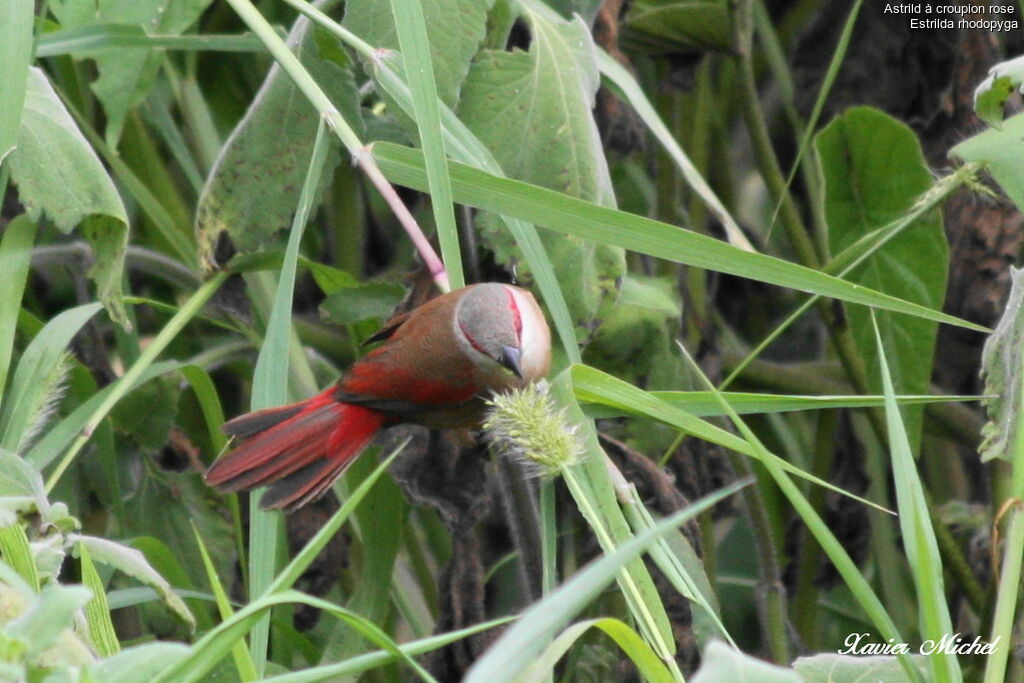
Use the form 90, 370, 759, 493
205, 283, 551, 512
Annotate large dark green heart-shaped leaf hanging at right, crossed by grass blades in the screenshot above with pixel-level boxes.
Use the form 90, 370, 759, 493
815, 106, 949, 452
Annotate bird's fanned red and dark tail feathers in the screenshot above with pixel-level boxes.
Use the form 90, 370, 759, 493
206, 387, 385, 512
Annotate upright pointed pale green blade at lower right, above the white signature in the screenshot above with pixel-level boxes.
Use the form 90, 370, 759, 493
871, 315, 964, 683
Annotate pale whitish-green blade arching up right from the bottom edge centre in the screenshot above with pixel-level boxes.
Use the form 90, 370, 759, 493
464, 481, 750, 683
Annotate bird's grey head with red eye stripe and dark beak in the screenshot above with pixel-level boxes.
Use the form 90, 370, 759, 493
455, 283, 551, 388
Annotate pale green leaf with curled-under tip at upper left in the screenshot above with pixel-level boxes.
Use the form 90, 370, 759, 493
8, 67, 128, 326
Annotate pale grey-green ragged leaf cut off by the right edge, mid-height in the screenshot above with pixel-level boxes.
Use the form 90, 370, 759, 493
978, 266, 1024, 462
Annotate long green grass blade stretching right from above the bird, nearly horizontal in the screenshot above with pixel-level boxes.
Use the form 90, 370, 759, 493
374, 142, 986, 332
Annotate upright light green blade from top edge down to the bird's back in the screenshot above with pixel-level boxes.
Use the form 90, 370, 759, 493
391, 0, 466, 289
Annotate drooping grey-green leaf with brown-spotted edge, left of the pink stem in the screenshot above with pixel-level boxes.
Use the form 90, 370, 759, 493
196, 17, 361, 267
